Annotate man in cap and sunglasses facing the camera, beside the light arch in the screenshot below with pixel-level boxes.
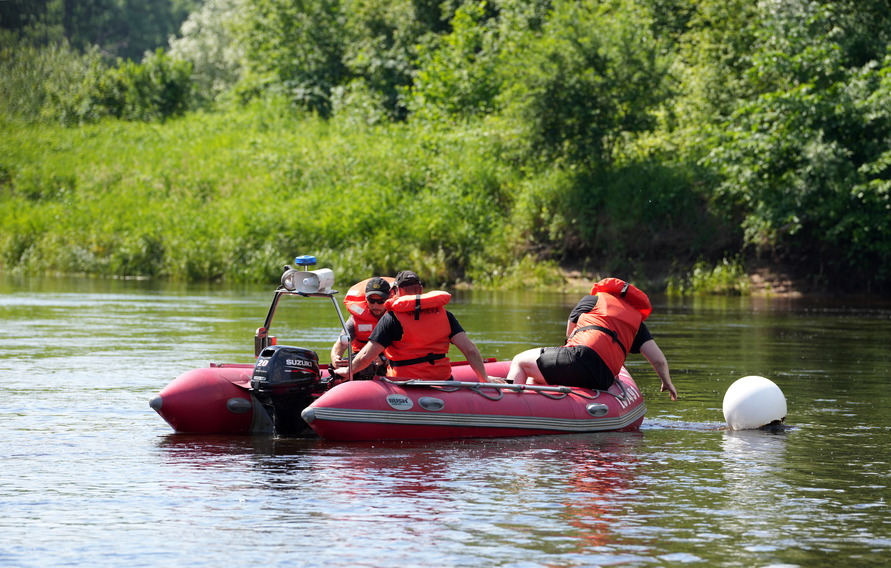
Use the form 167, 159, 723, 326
331, 276, 393, 379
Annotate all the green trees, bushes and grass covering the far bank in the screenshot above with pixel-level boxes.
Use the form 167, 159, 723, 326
0, 0, 891, 292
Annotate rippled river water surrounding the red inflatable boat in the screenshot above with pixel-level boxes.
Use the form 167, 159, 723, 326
0, 276, 891, 568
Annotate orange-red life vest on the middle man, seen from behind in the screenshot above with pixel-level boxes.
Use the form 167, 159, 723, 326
384, 291, 452, 380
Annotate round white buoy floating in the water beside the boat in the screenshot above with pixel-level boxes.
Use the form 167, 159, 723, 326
724, 375, 786, 430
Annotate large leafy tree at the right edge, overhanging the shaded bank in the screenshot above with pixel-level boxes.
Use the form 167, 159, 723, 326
706, 2, 891, 285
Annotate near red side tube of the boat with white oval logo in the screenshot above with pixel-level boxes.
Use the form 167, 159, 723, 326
302, 370, 646, 440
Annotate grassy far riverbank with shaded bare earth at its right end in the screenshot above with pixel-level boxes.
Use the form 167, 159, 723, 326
0, 110, 888, 296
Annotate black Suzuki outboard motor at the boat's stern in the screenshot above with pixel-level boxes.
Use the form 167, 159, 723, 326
251, 345, 321, 436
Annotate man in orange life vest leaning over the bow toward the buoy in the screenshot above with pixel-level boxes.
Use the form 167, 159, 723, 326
507, 278, 678, 400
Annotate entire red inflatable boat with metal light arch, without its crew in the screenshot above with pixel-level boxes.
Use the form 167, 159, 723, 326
149, 257, 646, 441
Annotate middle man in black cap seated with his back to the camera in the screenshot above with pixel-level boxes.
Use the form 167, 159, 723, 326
335, 270, 489, 382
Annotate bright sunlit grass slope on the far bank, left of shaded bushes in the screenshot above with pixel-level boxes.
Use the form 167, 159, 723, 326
0, 100, 580, 285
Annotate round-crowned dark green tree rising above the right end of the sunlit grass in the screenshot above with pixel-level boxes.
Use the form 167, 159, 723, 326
503, 0, 669, 168
